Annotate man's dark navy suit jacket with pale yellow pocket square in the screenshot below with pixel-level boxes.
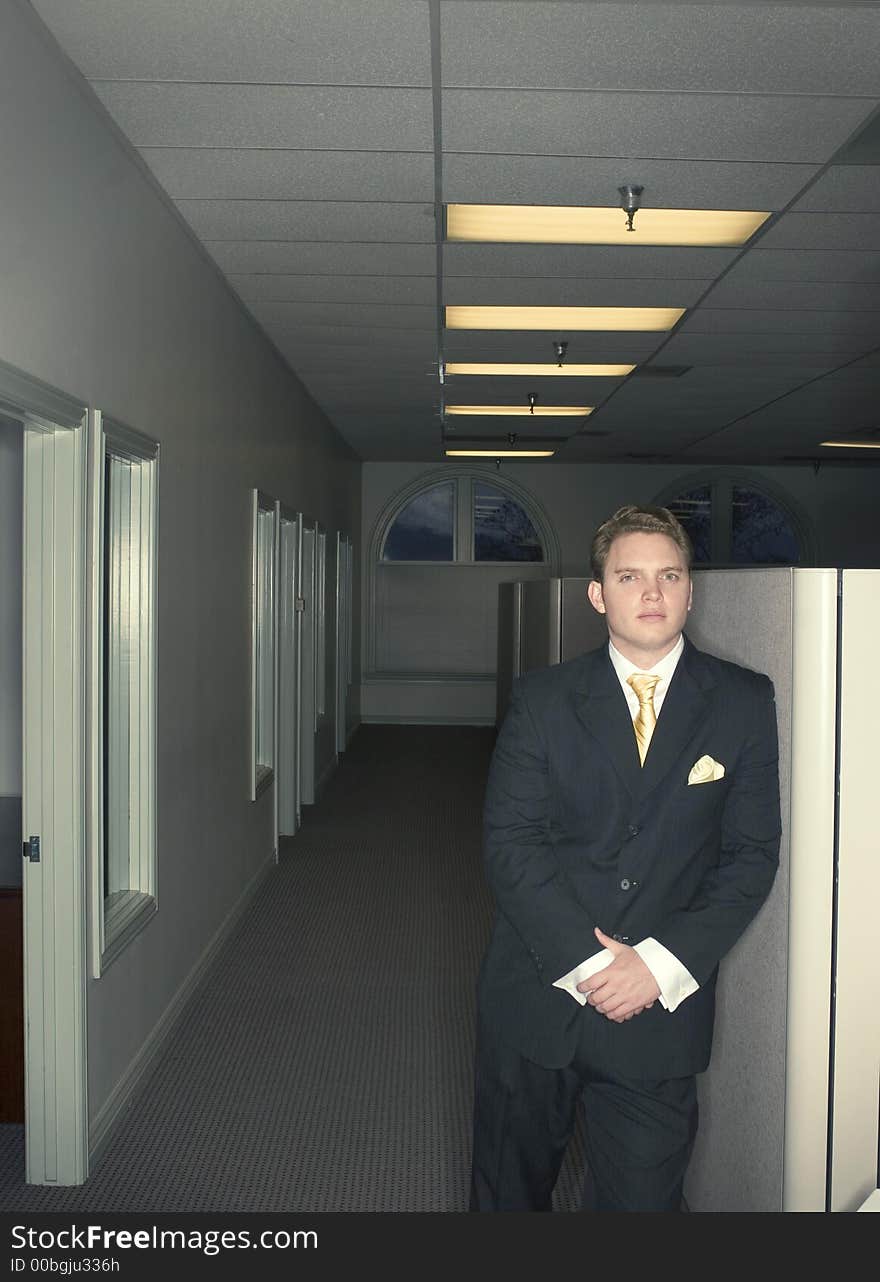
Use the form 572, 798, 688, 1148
478, 637, 780, 1079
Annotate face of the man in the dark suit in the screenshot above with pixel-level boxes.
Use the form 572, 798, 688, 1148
588, 533, 691, 668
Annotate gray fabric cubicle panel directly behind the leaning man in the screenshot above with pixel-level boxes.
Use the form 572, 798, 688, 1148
687, 568, 793, 1211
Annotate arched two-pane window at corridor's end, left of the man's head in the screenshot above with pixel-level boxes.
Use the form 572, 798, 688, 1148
380, 476, 546, 563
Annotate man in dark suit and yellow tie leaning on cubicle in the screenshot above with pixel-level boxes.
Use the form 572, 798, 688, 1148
471, 505, 780, 1211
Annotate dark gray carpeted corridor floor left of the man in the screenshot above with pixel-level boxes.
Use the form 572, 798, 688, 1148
0, 726, 592, 1213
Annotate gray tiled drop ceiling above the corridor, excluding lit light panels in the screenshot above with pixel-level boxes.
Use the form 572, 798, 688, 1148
24, 0, 880, 458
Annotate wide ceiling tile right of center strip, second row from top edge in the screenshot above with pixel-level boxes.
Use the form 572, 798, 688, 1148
443, 90, 874, 164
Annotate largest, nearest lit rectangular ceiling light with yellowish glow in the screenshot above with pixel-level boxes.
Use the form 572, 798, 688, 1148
446, 205, 770, 246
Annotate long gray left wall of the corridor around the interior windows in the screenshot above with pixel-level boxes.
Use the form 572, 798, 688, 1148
0, 0, 360, 1117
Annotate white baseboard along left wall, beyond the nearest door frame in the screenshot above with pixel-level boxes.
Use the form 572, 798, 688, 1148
89, 856, 276, 1167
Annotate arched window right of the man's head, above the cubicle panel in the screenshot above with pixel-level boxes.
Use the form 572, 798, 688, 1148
654, 473, 809, 565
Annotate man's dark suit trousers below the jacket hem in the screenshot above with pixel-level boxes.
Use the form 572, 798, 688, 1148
471, 1015, 698, 1211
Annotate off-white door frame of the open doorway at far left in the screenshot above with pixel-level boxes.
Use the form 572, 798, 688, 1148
0, 362, 91, 1185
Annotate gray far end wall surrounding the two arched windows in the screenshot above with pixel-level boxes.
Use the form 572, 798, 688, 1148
362, 463, 880, 723
